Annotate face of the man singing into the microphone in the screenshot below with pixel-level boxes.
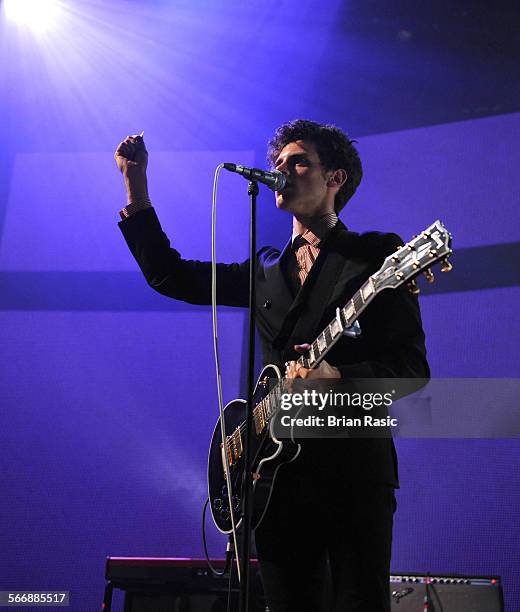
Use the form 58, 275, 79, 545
275, 140, 337, 217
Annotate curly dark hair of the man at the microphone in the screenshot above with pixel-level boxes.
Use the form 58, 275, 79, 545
267, 119, 363, 213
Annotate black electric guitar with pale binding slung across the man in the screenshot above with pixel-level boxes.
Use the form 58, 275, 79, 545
208, 221, 452, 533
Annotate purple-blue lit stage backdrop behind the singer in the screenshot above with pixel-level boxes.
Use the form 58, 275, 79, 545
0, 1, 520, 612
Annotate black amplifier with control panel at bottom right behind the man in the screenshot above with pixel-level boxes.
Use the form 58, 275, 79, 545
390, 574, 504, 612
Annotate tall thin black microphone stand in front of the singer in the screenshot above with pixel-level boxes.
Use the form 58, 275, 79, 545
239, 181, 258, 612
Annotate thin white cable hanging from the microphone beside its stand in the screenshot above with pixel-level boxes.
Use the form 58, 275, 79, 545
211, 164, 241, 582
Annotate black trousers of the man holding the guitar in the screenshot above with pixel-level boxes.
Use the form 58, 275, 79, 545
255, 462, 396, 612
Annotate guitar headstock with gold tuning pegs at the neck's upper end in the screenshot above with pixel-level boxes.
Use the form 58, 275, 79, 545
372, 220, 453, 294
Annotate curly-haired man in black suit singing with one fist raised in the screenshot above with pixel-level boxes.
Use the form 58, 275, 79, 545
115, 120, 429, 612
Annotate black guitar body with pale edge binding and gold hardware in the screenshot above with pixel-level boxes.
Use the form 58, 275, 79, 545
208, 365, 300, 533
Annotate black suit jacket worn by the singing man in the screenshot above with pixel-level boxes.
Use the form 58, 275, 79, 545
119, 208, 429, 486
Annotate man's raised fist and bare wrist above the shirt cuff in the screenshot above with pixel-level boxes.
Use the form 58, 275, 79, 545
114, 135, 148, 202
